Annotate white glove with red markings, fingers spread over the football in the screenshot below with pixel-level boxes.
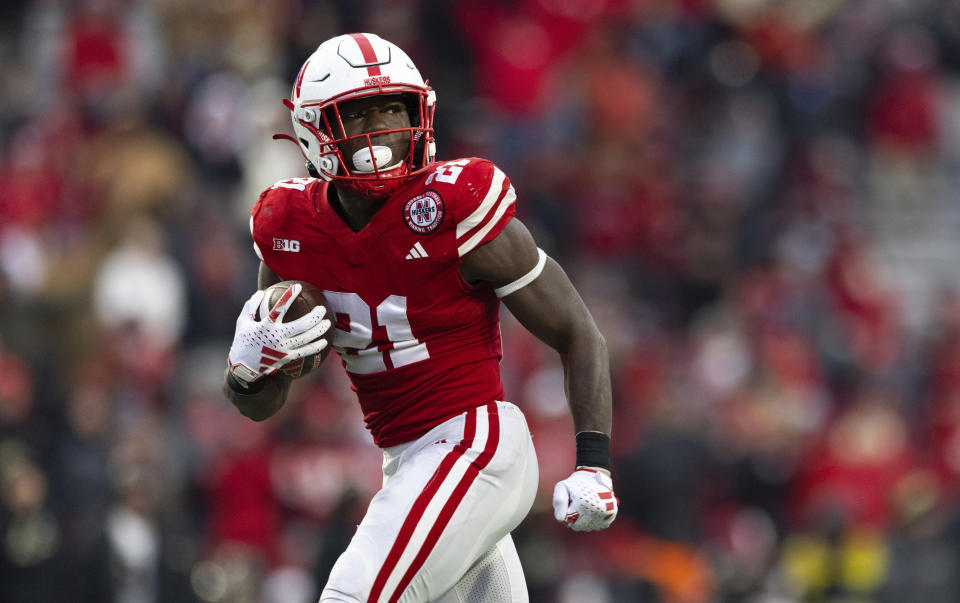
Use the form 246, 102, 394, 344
227, 284, 330, 384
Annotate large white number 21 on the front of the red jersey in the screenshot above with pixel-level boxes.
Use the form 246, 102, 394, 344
323, 291, 430, 375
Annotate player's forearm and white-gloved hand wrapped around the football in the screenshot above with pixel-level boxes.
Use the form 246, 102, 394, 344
223, 262, 329, 421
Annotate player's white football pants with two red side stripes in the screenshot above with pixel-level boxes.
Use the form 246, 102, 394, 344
320, 402, 539, 603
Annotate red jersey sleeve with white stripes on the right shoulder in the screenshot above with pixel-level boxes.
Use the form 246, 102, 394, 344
447, 159, 517, 258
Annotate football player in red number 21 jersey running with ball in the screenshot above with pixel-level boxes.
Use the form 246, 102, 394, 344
224, 34, 618, 603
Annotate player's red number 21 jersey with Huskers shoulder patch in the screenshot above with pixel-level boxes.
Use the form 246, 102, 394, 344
251, 158, 516, 447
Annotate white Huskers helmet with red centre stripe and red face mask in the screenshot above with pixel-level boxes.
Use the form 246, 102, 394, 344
274, 33, 437, 198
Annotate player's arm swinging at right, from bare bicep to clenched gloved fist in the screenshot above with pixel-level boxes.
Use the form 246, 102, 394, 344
460, 218, 617, 530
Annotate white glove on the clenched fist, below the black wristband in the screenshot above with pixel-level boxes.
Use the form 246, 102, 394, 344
553, 467, 620, 532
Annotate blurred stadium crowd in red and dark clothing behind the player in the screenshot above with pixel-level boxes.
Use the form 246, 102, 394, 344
0, 0, 960, 603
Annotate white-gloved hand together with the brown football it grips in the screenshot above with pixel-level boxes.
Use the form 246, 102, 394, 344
228, 281, 333, 383
